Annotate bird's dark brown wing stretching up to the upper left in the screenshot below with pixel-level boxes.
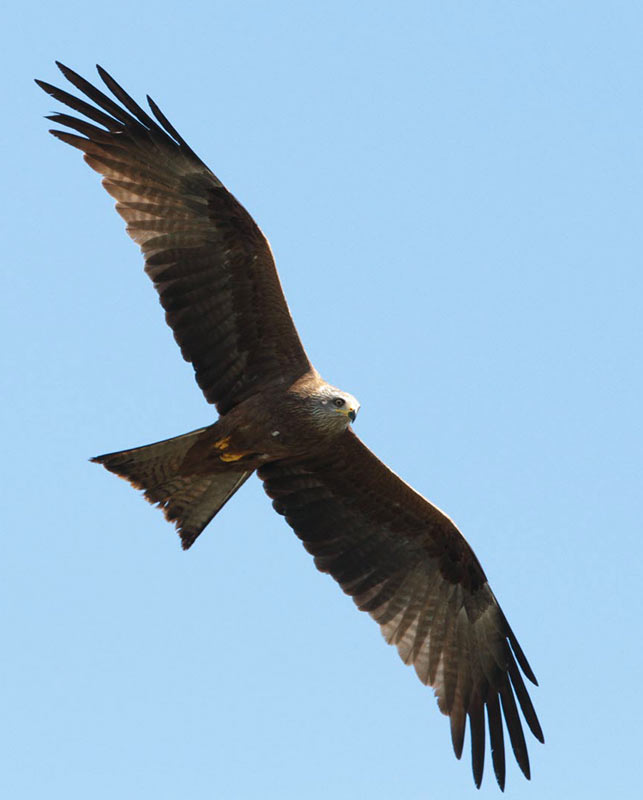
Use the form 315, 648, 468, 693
36, 64, 310, 413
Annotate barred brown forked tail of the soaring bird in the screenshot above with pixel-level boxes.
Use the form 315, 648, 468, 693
91, 428, 253, 550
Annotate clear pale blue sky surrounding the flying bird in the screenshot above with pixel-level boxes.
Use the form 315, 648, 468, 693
0, 0, 643, 800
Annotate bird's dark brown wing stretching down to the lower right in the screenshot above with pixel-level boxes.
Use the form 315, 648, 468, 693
259, 430, 544, 788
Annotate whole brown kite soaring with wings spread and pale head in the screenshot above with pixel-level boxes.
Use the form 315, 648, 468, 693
36, 62, 544, 790
